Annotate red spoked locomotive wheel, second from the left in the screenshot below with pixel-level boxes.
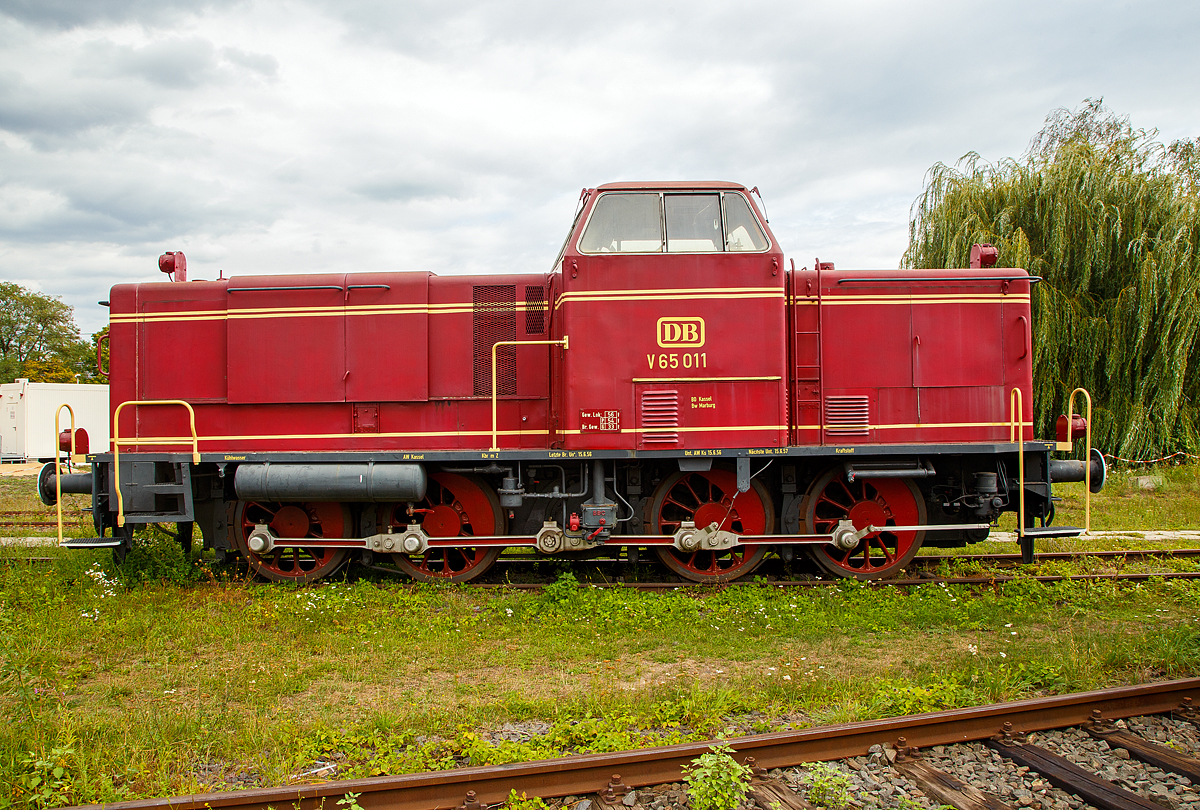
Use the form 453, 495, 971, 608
379, 473, 505, 582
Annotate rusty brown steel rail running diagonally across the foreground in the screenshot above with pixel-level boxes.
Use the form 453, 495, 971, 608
68, 678, 1200, 810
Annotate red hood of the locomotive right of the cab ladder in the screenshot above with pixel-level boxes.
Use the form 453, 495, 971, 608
811, 268, 1033, 444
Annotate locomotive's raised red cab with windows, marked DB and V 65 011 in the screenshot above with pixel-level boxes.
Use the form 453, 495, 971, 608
554, 182, 787, 452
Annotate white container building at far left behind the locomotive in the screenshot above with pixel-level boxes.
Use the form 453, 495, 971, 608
0, 379, 109, 462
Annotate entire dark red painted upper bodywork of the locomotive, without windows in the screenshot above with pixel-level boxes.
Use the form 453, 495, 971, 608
110, 184, 1032, 457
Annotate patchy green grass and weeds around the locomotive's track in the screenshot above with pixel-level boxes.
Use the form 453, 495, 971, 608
0, 468, 1200, 806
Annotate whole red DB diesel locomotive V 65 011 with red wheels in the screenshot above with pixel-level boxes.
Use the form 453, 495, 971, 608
43, 182, 1104, 582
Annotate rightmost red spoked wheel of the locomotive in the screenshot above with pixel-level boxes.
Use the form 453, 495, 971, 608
804, 468, 925, 580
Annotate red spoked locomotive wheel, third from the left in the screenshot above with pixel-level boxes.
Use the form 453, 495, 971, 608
649, 469, 775, 582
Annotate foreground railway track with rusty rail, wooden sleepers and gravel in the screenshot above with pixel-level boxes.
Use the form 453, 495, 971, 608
65, 678, 1200, 810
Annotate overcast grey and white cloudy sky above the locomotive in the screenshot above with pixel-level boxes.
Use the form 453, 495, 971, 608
0, 0, 1200, 334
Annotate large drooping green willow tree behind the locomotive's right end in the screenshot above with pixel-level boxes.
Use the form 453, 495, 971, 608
904, 100, 1200, 458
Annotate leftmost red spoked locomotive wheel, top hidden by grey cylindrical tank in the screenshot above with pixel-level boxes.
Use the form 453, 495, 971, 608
233, 500, 350, 582
